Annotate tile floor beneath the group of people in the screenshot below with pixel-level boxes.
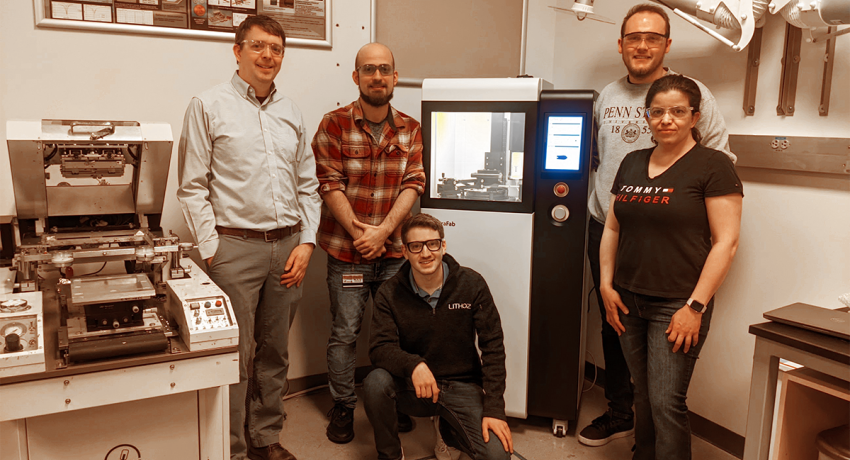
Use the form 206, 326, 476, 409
281, 387, 735, 460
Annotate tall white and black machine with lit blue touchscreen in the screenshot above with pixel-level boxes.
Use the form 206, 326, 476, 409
422, 78, 596, 436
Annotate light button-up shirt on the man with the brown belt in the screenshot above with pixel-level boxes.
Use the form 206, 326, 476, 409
177, 73, 322, 259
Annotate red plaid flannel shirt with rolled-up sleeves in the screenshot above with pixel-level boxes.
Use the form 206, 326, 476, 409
311, 100, 425, 264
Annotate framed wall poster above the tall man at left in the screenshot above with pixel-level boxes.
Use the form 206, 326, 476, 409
33, 0, 331, 48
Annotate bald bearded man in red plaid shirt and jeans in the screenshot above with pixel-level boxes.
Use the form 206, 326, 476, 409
312, 43, 425, 443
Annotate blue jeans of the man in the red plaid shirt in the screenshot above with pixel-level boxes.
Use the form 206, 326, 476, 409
328, 256, 404, 409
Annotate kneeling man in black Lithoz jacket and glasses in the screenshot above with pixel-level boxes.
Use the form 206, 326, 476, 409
363, 214, 513, 460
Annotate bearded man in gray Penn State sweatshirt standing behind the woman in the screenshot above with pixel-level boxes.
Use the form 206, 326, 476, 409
578, 4, 736, 446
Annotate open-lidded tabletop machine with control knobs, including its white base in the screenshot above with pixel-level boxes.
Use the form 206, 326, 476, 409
0, 120, 238, 460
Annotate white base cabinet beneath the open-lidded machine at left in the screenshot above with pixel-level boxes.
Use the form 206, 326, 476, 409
0, 352, 238, 460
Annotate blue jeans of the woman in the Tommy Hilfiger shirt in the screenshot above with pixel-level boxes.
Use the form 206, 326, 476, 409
616, 287, 714, 460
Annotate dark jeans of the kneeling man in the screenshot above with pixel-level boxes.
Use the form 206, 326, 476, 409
363, 368, 511, 460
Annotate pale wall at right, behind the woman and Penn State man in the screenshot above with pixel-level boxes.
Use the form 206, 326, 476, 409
527, 0, 850, 435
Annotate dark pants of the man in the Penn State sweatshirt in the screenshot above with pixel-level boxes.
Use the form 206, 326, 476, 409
587, 217, 635, 419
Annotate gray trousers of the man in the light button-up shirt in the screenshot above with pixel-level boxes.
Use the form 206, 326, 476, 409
209, 233, 301, 460
